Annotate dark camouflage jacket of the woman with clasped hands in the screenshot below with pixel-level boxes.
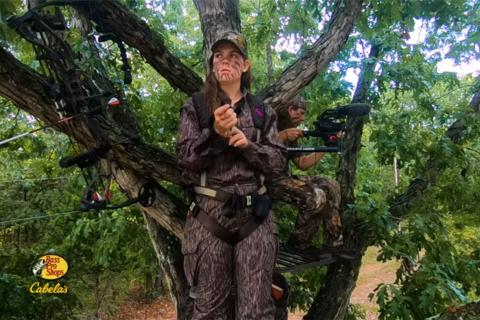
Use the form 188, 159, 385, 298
177, 93, 286, 194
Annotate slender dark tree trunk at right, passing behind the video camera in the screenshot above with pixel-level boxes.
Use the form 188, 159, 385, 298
304, 45, 380, 320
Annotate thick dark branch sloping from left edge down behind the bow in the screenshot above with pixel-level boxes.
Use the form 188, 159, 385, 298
0, 47, 186, 239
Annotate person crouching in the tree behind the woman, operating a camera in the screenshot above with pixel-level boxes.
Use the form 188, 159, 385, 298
267, 96, 343, 260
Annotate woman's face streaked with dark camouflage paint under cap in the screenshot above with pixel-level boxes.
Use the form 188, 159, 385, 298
212, 42, 250, 84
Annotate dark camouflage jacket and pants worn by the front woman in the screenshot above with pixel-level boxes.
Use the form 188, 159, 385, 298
177, 91, 285, 320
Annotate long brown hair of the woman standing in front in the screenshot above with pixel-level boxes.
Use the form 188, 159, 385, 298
203, 55, 252, 115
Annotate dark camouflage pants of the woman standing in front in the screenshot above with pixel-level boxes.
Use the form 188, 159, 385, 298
182, 199, 277, 320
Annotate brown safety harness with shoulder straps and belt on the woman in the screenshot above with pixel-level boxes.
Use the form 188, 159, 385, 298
189, 92, 271, 245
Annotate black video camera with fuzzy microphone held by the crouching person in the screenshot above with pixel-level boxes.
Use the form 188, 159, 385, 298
287, 103, 370, 153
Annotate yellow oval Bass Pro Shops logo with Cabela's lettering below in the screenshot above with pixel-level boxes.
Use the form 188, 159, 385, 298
30, 254, 68, 293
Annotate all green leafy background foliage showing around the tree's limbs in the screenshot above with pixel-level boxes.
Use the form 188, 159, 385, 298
0, 0, 480, 319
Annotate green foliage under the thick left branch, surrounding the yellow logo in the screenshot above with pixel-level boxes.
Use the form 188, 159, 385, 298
0, 100, 158, 319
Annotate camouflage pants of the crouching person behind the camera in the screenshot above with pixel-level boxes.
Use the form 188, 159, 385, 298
267, 176, 342, 247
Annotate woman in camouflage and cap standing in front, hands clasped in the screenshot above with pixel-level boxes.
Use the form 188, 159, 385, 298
177, 32, 286, 320
